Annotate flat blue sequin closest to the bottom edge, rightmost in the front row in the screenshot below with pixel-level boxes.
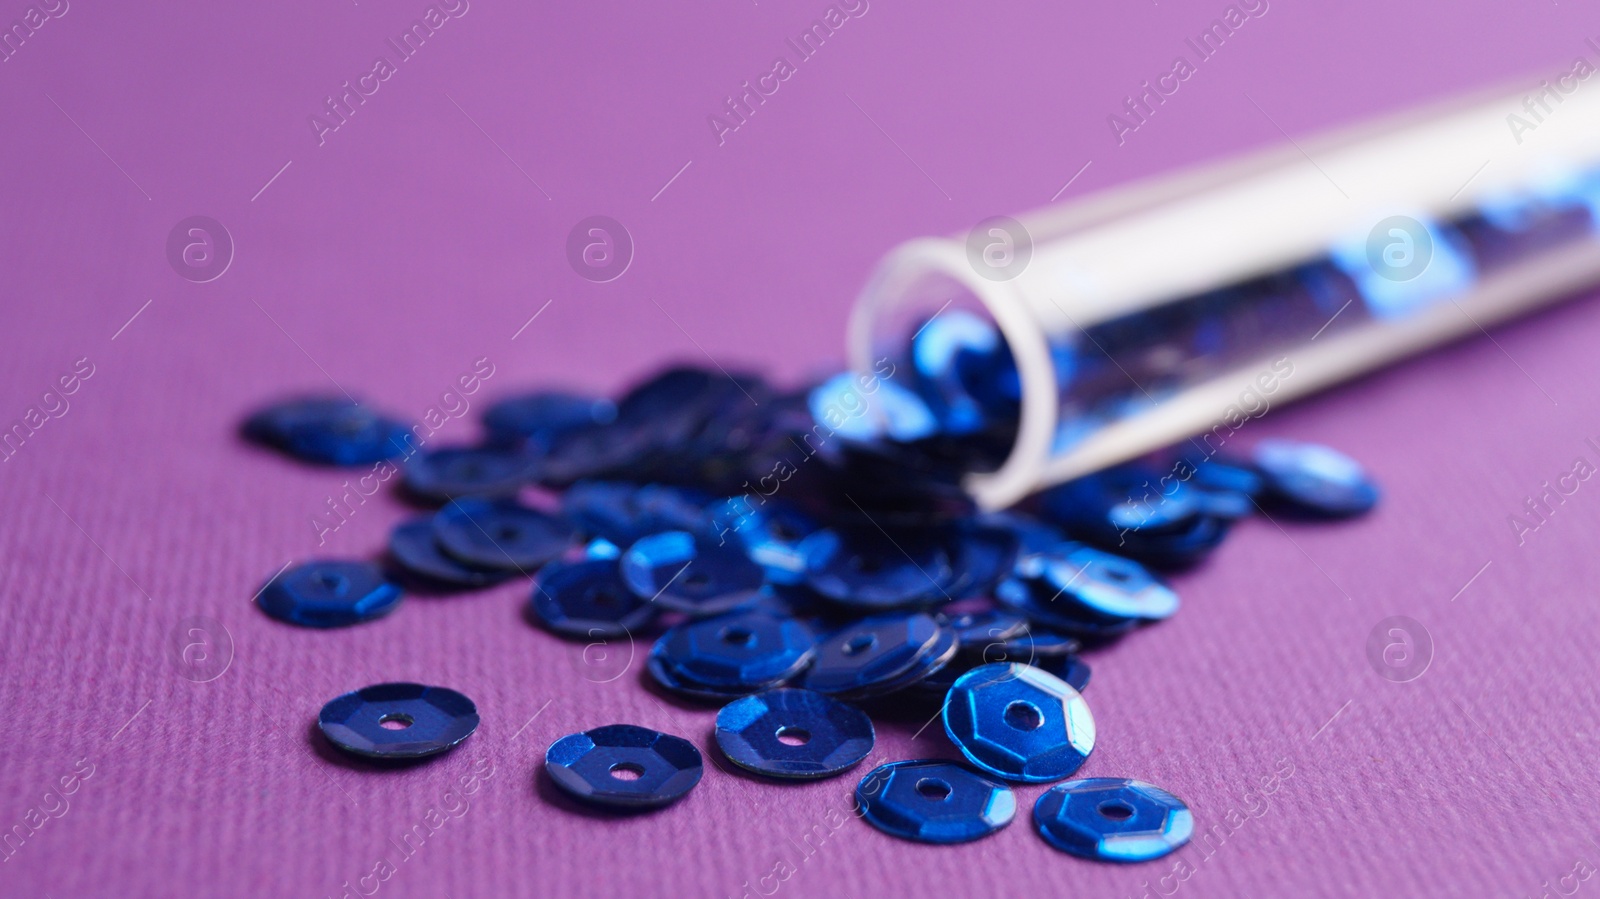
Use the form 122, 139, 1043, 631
1034, 777, 1195, 862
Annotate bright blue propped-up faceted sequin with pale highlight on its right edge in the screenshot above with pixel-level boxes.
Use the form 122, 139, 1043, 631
944, 664, 1094, 784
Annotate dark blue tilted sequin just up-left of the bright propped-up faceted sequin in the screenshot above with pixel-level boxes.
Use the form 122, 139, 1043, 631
805, 613, 955, 696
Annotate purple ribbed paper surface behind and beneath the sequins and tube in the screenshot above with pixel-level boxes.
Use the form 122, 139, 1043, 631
0, 0, 1600, 899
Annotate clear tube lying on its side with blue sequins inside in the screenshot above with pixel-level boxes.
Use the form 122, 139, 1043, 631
850, 75, 1600, 509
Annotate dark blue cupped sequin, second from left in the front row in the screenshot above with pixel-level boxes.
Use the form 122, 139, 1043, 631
544, 725, 704, 809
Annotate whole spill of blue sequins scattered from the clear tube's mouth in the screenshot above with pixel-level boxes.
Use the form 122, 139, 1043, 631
243, 325, 1378, 862
